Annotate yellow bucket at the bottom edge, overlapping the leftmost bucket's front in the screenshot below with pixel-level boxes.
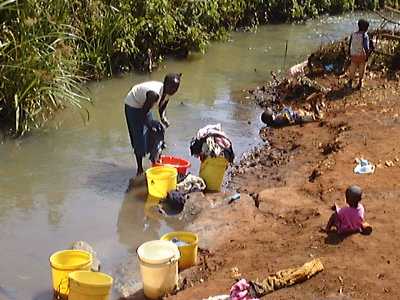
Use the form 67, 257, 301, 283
68, 271, 113, 300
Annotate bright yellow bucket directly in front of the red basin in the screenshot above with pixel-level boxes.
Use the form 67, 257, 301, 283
146, 166, 178, 199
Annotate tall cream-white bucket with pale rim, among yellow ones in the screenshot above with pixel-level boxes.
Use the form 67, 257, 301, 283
137, 240, 180, 299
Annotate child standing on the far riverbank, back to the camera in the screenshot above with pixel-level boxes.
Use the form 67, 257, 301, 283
348, 19, 371, 89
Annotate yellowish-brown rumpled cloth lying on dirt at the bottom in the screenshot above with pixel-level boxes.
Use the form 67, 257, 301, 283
250, 259, 324, 297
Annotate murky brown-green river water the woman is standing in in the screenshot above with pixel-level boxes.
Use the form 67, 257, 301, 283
0, 15, 378, 300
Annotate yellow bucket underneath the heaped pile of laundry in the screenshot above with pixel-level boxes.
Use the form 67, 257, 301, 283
200, 157, 228, 192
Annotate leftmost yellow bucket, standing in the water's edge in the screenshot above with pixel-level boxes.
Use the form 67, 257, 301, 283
50, 250, 92, 299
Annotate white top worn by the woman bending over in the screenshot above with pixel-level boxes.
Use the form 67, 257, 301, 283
125, 81, 164, 108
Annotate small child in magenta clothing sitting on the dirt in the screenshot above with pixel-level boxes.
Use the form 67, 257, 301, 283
325, 185, 372, 234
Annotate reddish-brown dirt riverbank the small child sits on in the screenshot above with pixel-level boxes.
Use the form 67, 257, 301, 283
160, 72, 400, 300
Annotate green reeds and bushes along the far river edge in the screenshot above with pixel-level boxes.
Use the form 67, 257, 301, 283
0, 0, 397, 135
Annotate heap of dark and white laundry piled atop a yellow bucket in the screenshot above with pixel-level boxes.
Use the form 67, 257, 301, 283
190, 124, 235, 162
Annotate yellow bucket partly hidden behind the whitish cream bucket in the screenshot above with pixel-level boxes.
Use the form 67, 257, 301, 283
161, 231, 199, 270
